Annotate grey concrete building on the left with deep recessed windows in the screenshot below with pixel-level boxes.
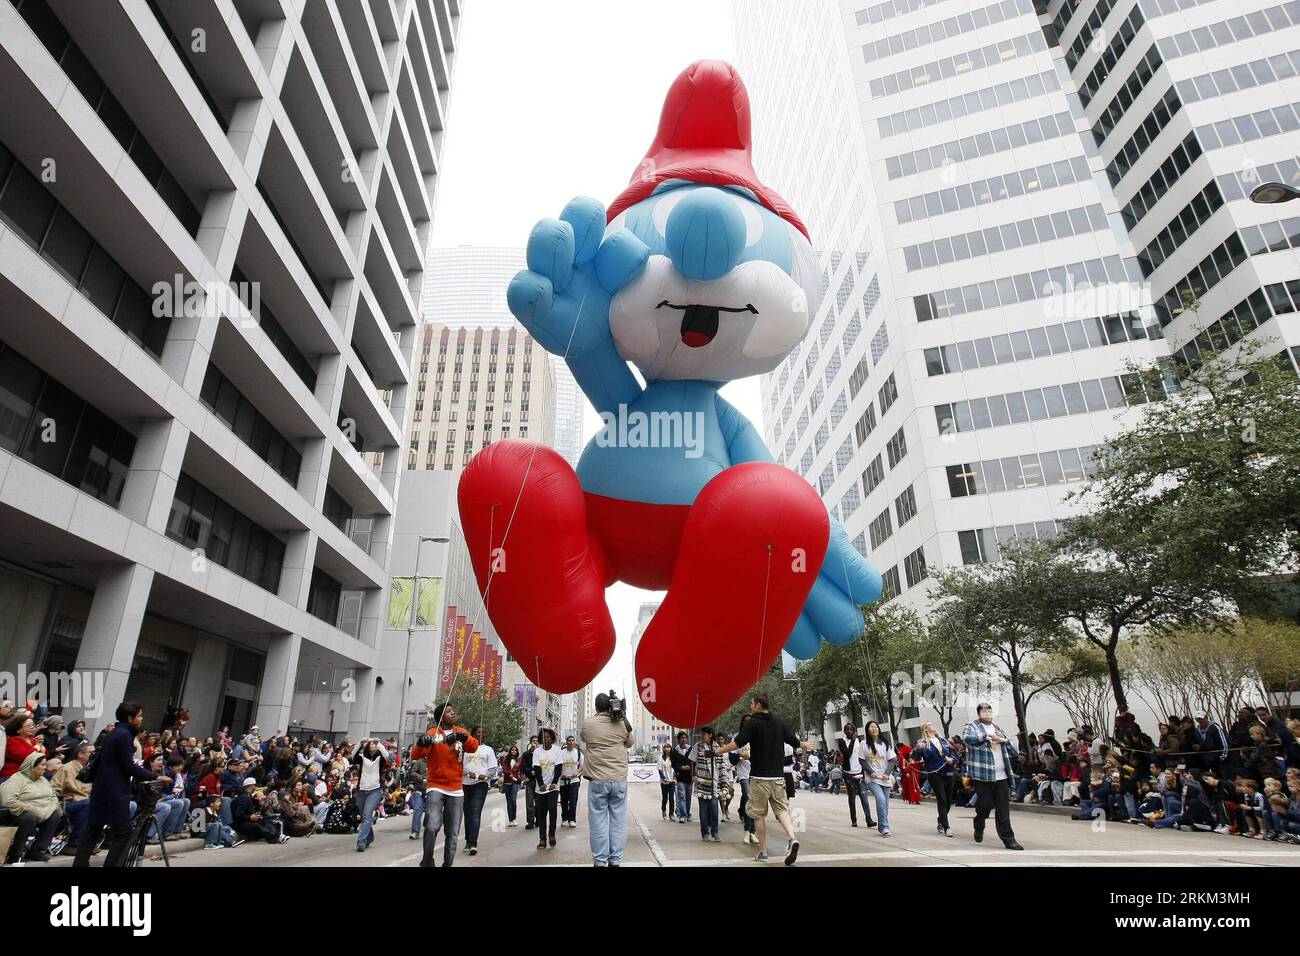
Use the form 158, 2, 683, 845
0, 0, 460, 736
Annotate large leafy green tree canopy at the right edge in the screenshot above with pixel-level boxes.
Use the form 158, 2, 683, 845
1073, 335, 1300, 605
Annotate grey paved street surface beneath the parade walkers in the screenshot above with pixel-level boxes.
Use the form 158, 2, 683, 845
51, 784, 1300, 869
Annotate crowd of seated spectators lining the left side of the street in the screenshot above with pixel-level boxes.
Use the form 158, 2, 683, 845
0, 701, 426, 865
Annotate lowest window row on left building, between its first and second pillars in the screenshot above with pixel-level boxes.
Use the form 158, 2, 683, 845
166, 472, 285, 593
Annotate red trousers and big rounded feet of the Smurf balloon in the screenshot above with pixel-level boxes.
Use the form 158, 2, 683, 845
459, 440, 829, 727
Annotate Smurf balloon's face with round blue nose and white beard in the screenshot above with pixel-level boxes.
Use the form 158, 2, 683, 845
608, 179, 818, 381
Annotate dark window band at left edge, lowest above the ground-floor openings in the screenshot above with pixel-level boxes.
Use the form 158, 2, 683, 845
0, 342, 135, 507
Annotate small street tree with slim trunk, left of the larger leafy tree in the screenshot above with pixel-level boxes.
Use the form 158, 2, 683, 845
933, 541, 1078, 749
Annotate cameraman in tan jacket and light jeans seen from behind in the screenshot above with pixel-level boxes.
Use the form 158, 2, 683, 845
579, 692, 632, 866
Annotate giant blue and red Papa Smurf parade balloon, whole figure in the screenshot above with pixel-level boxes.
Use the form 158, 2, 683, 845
459, 61, 881, 727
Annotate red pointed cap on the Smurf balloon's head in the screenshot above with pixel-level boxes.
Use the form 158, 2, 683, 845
607, 60, 809, 237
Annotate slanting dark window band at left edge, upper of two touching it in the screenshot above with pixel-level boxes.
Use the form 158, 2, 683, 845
0, 143, 172, 358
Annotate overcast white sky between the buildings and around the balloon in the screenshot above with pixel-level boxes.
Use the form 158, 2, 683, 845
433, 0, 759, 693
